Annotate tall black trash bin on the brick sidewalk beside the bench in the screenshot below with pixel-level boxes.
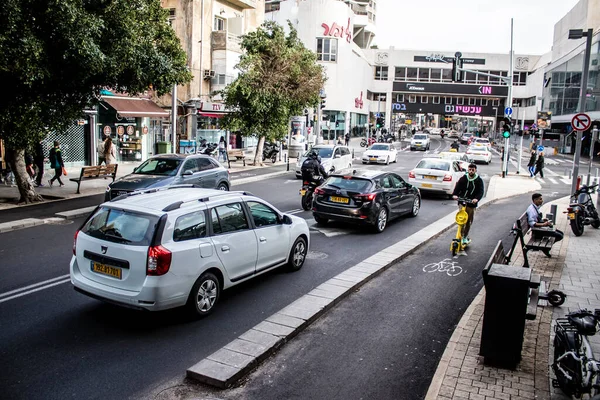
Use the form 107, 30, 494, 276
479, 264, 533, 369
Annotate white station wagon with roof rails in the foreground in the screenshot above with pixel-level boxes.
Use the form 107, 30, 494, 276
70, 187, 310, 316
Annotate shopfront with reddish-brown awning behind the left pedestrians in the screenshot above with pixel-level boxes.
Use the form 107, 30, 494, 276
98, 96, 169, 164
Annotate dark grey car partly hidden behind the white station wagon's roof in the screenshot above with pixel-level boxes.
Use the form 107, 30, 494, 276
104, 154, 231, 201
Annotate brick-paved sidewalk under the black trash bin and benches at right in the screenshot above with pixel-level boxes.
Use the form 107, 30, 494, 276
426, 192, 600, 400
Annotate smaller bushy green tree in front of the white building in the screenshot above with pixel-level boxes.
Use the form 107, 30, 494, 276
222, 21, 325, 165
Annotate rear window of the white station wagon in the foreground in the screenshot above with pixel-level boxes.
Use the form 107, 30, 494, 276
81, 207, 158, 246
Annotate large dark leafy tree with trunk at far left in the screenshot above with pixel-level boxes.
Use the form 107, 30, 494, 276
0, 0, 191, 203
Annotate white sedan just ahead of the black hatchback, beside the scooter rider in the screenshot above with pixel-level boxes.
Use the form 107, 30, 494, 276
408, 158, 464, 196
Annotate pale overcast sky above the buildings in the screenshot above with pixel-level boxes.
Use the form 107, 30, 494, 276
375, 0, 579, 55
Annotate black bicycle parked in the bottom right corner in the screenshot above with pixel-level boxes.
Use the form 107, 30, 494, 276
552, 309, 600, 399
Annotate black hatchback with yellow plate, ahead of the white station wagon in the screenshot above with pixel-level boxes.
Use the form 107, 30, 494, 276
312, 169, 421, 232
